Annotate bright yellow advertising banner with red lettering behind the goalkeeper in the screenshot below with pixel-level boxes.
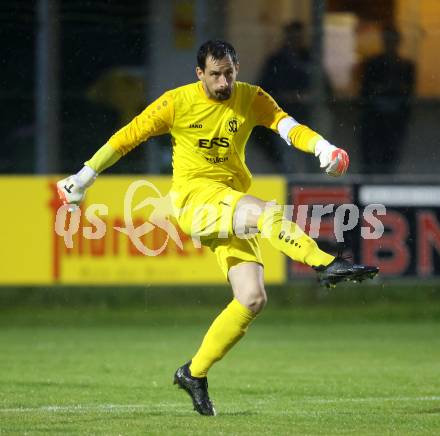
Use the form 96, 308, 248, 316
0, 176, 286, 285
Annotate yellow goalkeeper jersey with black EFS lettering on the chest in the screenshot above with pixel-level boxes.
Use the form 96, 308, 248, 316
105, 82, 288, 192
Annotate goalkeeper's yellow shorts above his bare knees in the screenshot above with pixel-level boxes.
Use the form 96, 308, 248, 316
171, 179, 263, 278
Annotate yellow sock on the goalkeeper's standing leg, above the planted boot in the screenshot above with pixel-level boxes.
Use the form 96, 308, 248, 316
189, 298, 256, 377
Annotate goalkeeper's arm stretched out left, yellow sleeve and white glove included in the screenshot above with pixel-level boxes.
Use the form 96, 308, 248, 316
57, 93, 174, 208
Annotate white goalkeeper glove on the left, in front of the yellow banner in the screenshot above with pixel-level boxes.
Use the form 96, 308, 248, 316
57, 166, 98, 212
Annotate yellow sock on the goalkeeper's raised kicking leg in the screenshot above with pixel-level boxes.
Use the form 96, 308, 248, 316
258, 205, 334, 266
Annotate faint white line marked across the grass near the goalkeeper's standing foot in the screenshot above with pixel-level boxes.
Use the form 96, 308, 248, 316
0, 396, 440, 413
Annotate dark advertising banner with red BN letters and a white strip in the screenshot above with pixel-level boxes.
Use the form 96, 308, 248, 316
288, 178, 440, 280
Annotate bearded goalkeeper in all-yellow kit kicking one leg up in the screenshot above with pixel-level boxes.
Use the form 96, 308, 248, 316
57, 40, 378, 415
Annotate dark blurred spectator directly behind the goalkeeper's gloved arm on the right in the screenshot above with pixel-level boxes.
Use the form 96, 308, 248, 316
257, 21, 330, 172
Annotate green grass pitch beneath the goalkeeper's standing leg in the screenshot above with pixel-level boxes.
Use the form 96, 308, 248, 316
0, 296, 440, 435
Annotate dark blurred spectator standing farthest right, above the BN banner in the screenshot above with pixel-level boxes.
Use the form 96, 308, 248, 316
361, 27, 415, 173
